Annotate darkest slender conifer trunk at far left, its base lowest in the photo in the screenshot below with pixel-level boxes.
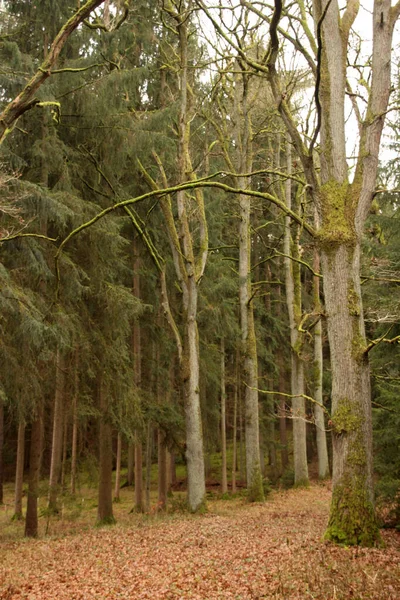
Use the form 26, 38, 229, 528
25, 405, 44, 537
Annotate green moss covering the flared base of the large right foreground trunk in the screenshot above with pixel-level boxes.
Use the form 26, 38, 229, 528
324, 475, 381, 547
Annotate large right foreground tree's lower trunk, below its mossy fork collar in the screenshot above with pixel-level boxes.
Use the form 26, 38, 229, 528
321, 244, 379, 545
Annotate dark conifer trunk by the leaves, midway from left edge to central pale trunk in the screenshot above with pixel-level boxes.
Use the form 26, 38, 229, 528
97, 376, 115, 525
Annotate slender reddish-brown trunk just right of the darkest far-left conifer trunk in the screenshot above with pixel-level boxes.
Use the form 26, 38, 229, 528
49, 350, 65, 513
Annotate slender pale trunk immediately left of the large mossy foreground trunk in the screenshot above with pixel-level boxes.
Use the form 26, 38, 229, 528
313, 248, 329, 479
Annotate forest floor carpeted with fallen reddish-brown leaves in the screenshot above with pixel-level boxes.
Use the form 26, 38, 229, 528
0, 485, 400, 600
